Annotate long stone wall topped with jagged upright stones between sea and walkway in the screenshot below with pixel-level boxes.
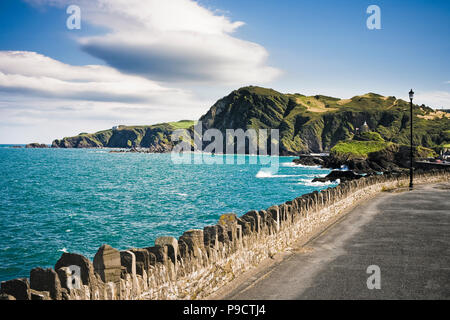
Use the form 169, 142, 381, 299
0, 170, 450, 300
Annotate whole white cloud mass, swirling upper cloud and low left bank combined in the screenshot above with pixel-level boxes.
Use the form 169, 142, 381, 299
0, 0, 280, 143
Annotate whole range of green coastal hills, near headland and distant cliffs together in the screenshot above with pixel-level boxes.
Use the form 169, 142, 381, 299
53, 86, 450, 155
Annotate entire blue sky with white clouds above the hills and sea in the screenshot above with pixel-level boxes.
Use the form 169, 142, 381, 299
0, 0, 450, 144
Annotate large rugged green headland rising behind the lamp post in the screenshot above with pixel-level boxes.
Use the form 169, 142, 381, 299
200, 87, 450, 155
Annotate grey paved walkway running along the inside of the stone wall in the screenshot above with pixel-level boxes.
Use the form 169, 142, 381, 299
225, 183, 450, 299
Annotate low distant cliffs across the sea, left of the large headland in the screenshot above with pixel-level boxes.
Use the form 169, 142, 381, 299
52, 120, 194, 152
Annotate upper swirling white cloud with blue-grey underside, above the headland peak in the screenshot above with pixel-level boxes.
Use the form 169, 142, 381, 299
24, 0, 281, 86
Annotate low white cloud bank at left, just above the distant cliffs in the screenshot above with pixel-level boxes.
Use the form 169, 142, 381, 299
0, 51, 212, 143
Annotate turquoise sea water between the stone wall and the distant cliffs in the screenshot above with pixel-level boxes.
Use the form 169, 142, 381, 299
0, 146, 330, 280
